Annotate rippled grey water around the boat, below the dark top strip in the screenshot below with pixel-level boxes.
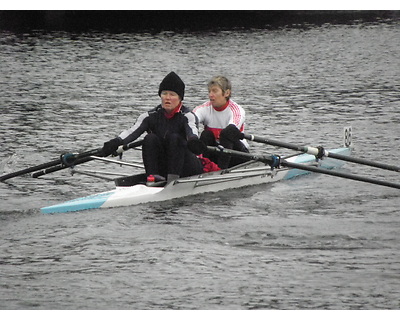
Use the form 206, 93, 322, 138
0, 23, 400, 309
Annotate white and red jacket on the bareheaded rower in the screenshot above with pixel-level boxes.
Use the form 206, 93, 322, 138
193, 99, 249, 148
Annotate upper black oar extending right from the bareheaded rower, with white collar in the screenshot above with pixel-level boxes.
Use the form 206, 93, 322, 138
244, 134, 400, 172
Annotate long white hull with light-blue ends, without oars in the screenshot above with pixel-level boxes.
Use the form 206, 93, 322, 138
41, 147, 351, 213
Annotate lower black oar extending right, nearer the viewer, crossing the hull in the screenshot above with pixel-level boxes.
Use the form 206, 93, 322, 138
207, 147, 400, 189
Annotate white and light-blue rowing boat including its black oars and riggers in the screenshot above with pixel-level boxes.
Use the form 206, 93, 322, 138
0, 127, 400, 213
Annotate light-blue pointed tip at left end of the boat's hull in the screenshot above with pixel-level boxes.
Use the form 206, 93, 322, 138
40, 191, 115, 213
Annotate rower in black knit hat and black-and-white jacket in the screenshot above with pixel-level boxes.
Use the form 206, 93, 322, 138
103, 72, 203, 182
